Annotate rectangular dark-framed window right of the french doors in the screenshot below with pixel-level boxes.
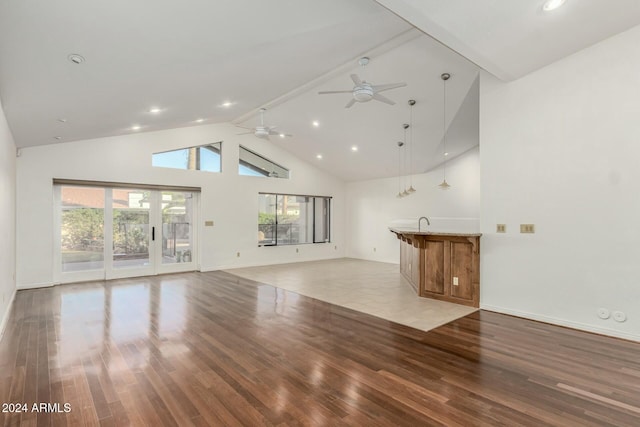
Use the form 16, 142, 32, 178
258, 193, 331, 246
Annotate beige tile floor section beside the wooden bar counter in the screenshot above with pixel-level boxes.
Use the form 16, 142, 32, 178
225, 258, 477, 331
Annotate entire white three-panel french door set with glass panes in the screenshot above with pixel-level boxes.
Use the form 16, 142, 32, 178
54, 185, 199, 283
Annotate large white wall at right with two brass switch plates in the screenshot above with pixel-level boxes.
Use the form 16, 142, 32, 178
480, 27, 640, 340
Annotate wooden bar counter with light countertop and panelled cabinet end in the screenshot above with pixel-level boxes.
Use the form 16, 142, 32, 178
389, 228, 481, 307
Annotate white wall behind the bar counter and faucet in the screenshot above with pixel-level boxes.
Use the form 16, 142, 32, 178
346, 147, 480, 263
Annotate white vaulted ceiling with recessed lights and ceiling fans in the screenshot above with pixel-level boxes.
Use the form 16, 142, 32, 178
0, 0, 640, 180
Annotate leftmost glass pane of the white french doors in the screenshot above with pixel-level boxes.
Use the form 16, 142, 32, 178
60, 187, 104, 272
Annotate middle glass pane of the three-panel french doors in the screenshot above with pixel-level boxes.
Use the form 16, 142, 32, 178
112, 188, 151, 268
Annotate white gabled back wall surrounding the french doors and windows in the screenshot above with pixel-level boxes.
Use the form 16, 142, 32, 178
17, 124, 344, 288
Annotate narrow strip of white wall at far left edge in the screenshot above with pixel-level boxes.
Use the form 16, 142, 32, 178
0, 100, 16, 337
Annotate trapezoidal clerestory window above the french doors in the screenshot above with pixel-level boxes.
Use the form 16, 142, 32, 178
151, 142, 222, 172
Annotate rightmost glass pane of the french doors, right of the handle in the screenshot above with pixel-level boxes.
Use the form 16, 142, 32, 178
161, 191, 193, 264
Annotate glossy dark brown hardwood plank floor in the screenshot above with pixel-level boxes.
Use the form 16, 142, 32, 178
0, 272, 640, 426
